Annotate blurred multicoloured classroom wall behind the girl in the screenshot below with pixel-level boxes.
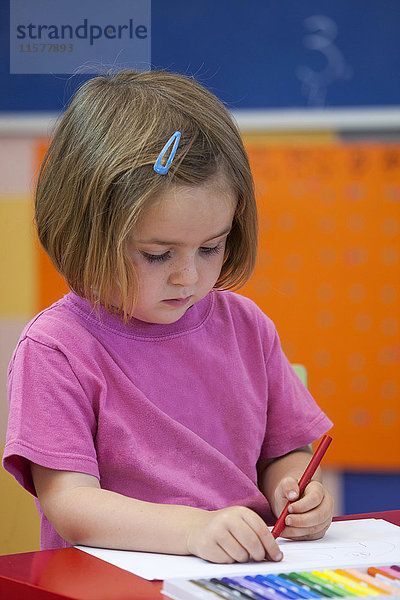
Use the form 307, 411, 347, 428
0, 0, 400, 554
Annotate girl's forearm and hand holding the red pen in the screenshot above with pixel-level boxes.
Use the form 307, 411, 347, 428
258, 446, 333, 540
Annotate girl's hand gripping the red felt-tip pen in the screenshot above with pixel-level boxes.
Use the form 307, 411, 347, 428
272, 477, 333, 540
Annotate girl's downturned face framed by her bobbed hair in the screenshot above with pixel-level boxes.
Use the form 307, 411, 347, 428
128, 177, 236, 324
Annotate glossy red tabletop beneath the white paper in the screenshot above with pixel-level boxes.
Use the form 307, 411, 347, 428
0, 510, 400, 600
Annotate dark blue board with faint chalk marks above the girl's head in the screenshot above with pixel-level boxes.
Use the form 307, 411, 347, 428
0, 0, 400, 111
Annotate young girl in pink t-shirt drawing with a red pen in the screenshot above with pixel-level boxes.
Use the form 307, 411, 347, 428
4, 71, 333, 563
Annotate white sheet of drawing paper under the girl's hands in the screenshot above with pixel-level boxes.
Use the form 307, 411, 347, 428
76, 519, 400, 580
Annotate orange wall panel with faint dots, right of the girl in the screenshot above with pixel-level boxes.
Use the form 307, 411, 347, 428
241, 138, 400, 469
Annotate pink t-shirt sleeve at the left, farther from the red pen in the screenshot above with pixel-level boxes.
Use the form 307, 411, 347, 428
3, 337, 99, 494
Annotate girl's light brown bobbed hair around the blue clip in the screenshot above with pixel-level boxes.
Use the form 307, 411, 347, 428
35, 70, 257, 321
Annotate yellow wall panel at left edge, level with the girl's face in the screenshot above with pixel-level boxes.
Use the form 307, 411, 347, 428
0, 194, 37, 317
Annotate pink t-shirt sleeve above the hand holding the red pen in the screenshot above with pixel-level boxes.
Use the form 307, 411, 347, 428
260, 320, 333, 458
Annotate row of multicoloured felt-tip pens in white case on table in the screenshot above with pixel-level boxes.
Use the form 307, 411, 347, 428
162, 565, 400, 600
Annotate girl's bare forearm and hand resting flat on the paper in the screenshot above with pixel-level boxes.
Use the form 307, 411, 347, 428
31, 463, 282, 563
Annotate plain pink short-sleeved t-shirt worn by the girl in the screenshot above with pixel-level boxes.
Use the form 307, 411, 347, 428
3, 292, 332, 548
